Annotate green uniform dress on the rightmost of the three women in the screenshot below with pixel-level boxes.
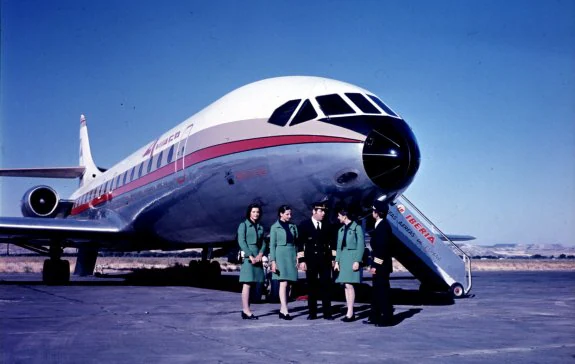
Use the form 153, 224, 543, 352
335, 221, 365, 283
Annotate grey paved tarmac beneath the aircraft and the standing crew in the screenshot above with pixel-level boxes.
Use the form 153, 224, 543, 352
0, 271, 575, 364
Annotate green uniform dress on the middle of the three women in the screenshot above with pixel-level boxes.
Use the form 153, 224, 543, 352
270, 220, 297, 282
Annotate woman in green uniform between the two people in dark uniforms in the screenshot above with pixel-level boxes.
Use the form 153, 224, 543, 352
334, 208, 365, 322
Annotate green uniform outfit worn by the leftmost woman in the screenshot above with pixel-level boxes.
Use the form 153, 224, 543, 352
238, 219, 266, 283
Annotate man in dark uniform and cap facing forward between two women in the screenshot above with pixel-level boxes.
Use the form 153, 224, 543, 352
297, 202, 335, 320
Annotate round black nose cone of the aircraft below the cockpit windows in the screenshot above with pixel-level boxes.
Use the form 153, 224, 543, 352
363, 119, 421, 195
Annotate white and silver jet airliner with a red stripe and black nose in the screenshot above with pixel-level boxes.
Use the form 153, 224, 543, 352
0, 76, 420, 283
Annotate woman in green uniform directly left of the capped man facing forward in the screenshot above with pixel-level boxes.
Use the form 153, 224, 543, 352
270, 205, 297, 320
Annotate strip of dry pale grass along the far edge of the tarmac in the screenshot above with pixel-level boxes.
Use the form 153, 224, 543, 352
0, 256, 575, 273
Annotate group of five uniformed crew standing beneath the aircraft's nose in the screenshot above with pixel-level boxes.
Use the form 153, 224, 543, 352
237, 201, 393, 326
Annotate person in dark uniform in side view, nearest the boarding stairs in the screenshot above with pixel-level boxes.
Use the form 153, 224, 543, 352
363, 200, 393, 326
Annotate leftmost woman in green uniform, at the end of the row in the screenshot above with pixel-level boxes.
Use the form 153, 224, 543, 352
238, 204, 266, 320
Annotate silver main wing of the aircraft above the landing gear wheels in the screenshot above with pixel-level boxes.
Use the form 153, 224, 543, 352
0, 217, 127, 246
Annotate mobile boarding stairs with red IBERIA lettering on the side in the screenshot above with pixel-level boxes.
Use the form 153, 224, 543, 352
387, 196, 471, 298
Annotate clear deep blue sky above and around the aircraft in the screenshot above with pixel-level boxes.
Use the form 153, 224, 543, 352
0, 0, 575, 245
